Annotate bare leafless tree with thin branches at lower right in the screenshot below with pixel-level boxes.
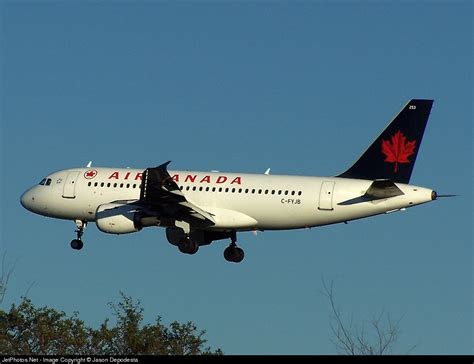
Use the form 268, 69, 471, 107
322, 279, 416, 355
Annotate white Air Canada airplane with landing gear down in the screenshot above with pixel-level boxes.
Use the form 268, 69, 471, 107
20, 99, 448, 263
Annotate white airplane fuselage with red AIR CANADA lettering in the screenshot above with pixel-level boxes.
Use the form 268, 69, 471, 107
21, 167, 433, 231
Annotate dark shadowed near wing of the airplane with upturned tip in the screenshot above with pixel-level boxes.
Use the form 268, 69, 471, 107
140, 161, 215, 225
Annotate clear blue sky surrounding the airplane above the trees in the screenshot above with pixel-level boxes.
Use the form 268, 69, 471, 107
0, 1, 474, 354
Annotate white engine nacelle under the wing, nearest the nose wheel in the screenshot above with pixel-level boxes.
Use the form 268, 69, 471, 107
95, 203, 142, 234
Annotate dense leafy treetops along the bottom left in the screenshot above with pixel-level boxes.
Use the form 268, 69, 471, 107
0, 293, 222, 355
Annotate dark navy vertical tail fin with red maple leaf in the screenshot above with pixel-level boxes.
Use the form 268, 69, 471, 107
337, 99, 433, 183
